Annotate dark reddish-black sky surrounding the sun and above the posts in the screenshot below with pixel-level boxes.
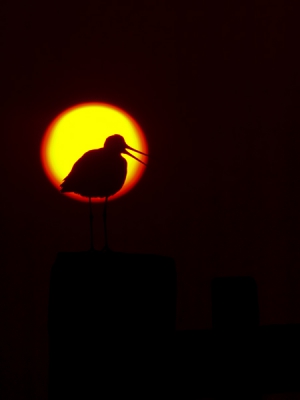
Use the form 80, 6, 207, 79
0, 0, 300, 399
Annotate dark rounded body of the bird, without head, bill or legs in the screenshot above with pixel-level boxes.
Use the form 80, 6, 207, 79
61, 148, 127, 197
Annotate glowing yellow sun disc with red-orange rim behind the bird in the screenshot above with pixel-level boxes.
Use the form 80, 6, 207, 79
41, 103, 148, 201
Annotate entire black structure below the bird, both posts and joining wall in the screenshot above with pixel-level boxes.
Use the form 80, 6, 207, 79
48, 266, 300, 400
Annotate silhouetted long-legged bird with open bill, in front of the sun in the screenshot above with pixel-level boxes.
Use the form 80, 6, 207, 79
60, 135, 147, 250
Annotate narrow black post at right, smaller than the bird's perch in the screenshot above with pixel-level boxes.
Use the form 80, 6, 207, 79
211, 277, 261, 400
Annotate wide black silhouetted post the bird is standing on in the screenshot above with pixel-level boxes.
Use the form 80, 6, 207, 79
48, 251, 176, 400
